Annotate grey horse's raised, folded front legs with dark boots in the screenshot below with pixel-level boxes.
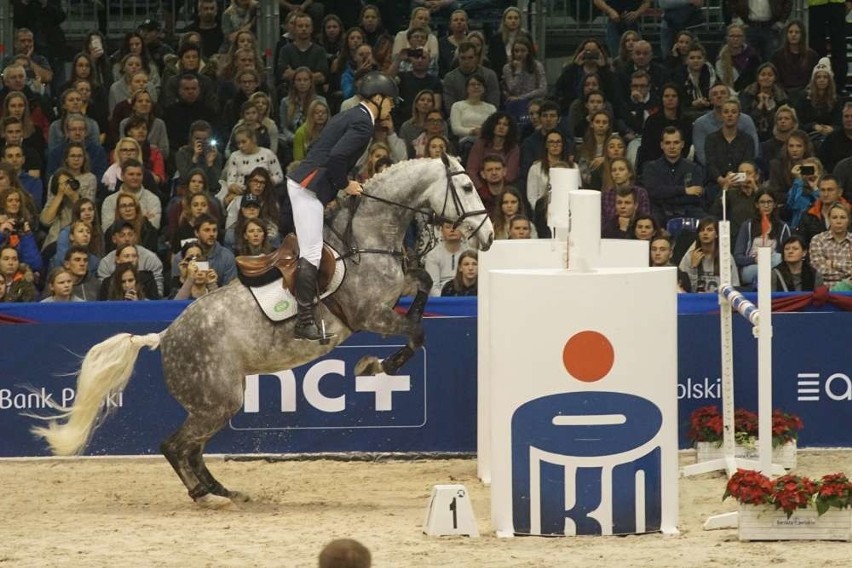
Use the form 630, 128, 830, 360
355, 302, 428, 376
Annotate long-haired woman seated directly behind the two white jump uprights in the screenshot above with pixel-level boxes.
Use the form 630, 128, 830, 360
734, 188, 792, 286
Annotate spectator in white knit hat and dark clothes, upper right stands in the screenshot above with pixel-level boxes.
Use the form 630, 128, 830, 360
797, 57, 843, 146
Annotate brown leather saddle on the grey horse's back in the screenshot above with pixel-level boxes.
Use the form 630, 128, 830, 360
235, 233, 337, 295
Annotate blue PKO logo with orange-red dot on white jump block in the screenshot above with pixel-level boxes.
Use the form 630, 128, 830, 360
511, 331, 663, 535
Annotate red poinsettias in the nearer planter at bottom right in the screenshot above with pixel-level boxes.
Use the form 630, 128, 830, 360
723, 469, 852, 518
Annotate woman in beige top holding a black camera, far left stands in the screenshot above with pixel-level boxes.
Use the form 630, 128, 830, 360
39, 162, 100, 250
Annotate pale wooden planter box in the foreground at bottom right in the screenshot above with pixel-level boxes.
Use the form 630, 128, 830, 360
737, 505, 852, 541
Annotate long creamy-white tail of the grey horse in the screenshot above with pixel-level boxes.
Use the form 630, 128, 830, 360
30, 333, 160, 456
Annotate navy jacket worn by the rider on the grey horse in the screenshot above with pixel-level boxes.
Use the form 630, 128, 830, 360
287, 104, 373, 205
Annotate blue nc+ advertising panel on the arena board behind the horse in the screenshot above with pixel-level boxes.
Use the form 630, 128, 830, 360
230, 345, 427, 430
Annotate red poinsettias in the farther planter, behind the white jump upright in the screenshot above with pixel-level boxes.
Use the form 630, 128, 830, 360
687, 406, 804, 447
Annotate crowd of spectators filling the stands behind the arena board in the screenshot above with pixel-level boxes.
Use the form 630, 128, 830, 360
0, 0, 852, 302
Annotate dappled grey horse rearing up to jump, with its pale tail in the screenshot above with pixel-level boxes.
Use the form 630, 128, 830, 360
33, 156, 494, 508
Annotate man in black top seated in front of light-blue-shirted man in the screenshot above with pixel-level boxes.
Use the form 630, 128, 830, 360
704, 97, 755, 203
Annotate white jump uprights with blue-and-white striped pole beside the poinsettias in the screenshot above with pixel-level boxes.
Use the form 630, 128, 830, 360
681, 221, 784, 530
